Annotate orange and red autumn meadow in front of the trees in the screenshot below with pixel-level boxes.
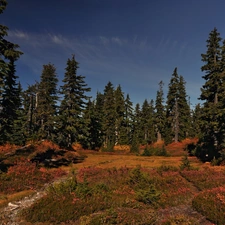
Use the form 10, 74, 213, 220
0, 142, 225, 225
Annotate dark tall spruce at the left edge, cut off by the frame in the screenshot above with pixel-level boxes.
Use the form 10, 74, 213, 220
0, 0, 22, 144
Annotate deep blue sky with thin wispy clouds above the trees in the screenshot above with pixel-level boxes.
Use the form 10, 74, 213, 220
0, 0, 225, 106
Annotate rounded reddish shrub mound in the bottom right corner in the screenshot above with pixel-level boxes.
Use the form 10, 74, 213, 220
192, 187, 225, 225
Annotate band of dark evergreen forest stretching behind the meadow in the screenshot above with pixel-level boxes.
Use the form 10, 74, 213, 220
0, 0, 225, 165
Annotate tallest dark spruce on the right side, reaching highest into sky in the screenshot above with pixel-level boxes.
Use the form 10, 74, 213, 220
200, 28, 225, 160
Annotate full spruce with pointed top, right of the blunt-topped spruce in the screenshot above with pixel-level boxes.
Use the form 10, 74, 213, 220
57, 55, 90, 148
